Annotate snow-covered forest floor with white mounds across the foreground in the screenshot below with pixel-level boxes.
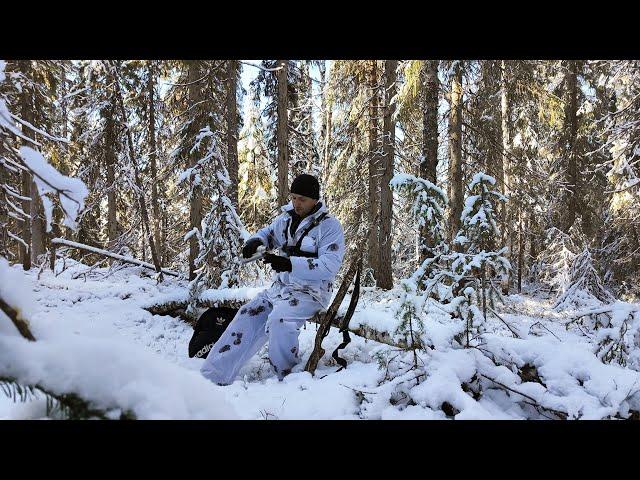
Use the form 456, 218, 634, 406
0, 261, 640, 419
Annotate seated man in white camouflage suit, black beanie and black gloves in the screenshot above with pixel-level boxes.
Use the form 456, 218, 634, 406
200, 174, 345, 385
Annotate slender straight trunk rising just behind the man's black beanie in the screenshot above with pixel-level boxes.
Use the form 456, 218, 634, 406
276, 60, 289, 206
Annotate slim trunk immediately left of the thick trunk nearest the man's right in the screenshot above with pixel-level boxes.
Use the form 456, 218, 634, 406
367, 60, 380, 283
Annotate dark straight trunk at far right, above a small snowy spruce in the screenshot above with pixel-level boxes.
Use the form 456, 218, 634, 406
563, 60, 578, 233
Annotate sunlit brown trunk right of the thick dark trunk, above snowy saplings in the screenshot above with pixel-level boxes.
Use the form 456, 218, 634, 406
449, 62, 464, 246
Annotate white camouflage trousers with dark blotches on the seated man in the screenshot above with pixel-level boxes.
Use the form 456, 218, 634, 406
200, 291, 322, 385
